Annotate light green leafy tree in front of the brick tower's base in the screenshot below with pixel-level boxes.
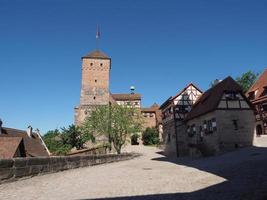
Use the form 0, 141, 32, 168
83, 105, 142, 154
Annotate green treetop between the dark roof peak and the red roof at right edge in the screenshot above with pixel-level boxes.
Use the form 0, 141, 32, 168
236, 71, 259, 93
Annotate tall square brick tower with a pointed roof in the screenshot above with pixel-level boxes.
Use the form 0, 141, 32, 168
75, 50, 111, 125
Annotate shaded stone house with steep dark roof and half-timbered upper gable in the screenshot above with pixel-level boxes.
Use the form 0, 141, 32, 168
184, 77, 255, 156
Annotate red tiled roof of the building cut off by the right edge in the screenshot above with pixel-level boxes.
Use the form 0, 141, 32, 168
246, 69, 267, 102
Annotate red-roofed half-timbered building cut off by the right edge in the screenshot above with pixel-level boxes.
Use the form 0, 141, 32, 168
247, 69, 267, 135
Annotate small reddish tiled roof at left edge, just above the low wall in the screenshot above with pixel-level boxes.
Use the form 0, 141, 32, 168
0, 137, 22, 159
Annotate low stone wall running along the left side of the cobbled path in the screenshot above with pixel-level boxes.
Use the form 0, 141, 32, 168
0, 153, 138, 184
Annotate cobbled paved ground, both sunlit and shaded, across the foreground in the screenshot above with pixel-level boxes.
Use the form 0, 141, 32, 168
0, 141, 267, 200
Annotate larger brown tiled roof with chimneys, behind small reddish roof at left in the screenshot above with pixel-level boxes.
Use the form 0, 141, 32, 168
0, 128, 49, 157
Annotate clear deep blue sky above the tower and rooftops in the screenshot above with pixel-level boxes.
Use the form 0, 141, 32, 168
0, 0, 267, 132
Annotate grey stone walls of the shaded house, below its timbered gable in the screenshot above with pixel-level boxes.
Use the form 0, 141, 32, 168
186, 110, 255, 156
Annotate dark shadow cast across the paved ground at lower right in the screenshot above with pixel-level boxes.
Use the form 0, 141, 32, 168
80, 147, 267, 200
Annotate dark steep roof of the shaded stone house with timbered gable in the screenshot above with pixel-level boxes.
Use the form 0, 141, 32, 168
185, 76, 251, 120
